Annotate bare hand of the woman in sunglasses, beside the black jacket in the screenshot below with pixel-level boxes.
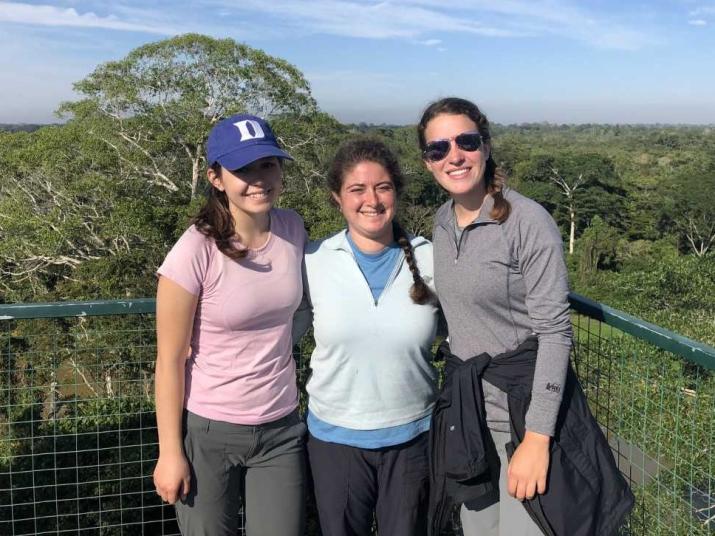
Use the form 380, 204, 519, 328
507, 430, 551, 501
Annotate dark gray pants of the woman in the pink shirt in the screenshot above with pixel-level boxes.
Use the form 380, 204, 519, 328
176, 410, 306, 536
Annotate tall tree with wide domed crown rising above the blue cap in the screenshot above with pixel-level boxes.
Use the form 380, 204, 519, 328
60, 34, 316, 198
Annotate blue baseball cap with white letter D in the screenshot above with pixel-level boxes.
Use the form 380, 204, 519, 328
206, 114, 293, 170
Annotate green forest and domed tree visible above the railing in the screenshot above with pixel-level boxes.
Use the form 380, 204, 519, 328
0, 34, 715, 345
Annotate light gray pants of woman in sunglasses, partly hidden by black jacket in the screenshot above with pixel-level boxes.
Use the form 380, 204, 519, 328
460, 430, 541, 536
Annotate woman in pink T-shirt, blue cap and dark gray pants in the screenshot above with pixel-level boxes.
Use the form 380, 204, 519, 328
154, 114, 306, 536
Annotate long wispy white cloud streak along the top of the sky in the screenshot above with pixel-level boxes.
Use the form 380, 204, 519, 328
0, 0, 656, 50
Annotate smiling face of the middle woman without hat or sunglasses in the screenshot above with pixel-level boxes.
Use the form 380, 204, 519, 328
332, 161, 397, 252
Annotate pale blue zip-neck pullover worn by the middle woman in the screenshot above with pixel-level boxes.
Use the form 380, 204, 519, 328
294, 231, 438, 430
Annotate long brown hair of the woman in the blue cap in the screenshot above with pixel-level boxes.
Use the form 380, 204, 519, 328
191, 162, 248, 261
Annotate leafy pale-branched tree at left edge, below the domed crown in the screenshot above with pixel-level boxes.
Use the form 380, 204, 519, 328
0, 122, 169, 301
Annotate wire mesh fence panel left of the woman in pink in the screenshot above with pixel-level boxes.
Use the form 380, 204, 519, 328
0, 315, 173, 536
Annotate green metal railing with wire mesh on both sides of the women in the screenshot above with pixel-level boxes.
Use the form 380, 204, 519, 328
0, 295, 715, 536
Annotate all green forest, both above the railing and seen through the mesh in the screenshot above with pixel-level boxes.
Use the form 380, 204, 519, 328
0, 34, 715, 535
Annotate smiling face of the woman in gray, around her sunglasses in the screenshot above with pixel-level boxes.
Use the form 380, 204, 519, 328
424, 114, 490, 202
